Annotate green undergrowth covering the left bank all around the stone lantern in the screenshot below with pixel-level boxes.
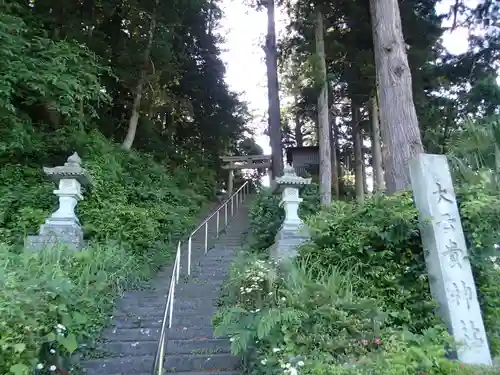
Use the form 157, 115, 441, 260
0, 128, 214, 375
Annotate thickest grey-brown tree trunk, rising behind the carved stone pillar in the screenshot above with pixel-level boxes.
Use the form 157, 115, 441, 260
370, 0, 423, 194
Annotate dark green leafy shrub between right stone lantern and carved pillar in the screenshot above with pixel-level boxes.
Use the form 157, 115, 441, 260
303, 194, 436, 331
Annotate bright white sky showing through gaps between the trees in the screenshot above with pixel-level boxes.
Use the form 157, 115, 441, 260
220, 0, 476, 154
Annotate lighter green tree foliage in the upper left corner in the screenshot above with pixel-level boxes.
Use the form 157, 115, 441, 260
0, 2, 108, 123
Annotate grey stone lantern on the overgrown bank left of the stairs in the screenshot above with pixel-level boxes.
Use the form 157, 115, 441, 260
25, 152, 91, 250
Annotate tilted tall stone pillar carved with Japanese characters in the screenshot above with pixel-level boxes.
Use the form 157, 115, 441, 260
410, 154, 492, 365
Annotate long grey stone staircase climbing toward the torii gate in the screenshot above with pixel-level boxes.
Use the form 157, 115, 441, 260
81, 197, 250, 375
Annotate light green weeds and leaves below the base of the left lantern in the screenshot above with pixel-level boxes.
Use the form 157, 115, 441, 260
0, 244, 151, 375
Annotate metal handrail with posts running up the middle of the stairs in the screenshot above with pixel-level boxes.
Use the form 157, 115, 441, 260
148, 181, 250, 375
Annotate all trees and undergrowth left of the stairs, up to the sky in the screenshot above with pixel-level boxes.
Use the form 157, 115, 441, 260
0, 0, 260, 375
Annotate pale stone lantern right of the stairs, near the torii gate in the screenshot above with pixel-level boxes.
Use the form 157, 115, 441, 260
270, 165, 311, 261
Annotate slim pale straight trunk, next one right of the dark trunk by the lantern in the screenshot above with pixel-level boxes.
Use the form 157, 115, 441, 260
316, 9, 332, 206
